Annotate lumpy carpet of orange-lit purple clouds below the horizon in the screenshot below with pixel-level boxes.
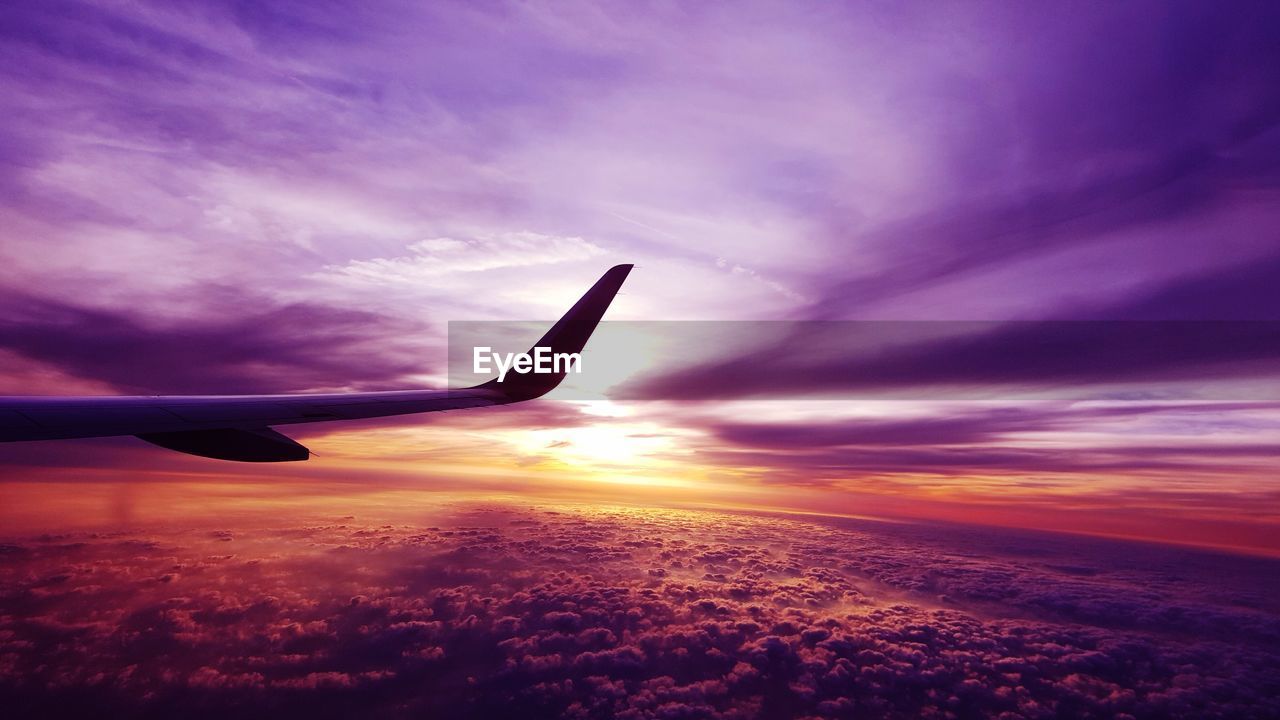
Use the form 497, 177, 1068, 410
0, 506, 1280, 717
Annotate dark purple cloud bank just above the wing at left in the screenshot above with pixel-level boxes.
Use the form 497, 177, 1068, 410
0, 287, 430, 393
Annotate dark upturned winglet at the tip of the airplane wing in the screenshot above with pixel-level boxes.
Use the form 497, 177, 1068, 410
472, 265, 634, 402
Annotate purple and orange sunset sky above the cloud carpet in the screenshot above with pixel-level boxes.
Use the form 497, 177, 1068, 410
0, 1, 1280, 555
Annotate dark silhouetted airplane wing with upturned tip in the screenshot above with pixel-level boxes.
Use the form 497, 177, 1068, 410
0, 265, 631, 462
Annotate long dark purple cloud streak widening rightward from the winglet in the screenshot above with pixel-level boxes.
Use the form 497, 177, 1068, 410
621, 259, 1280, 398
